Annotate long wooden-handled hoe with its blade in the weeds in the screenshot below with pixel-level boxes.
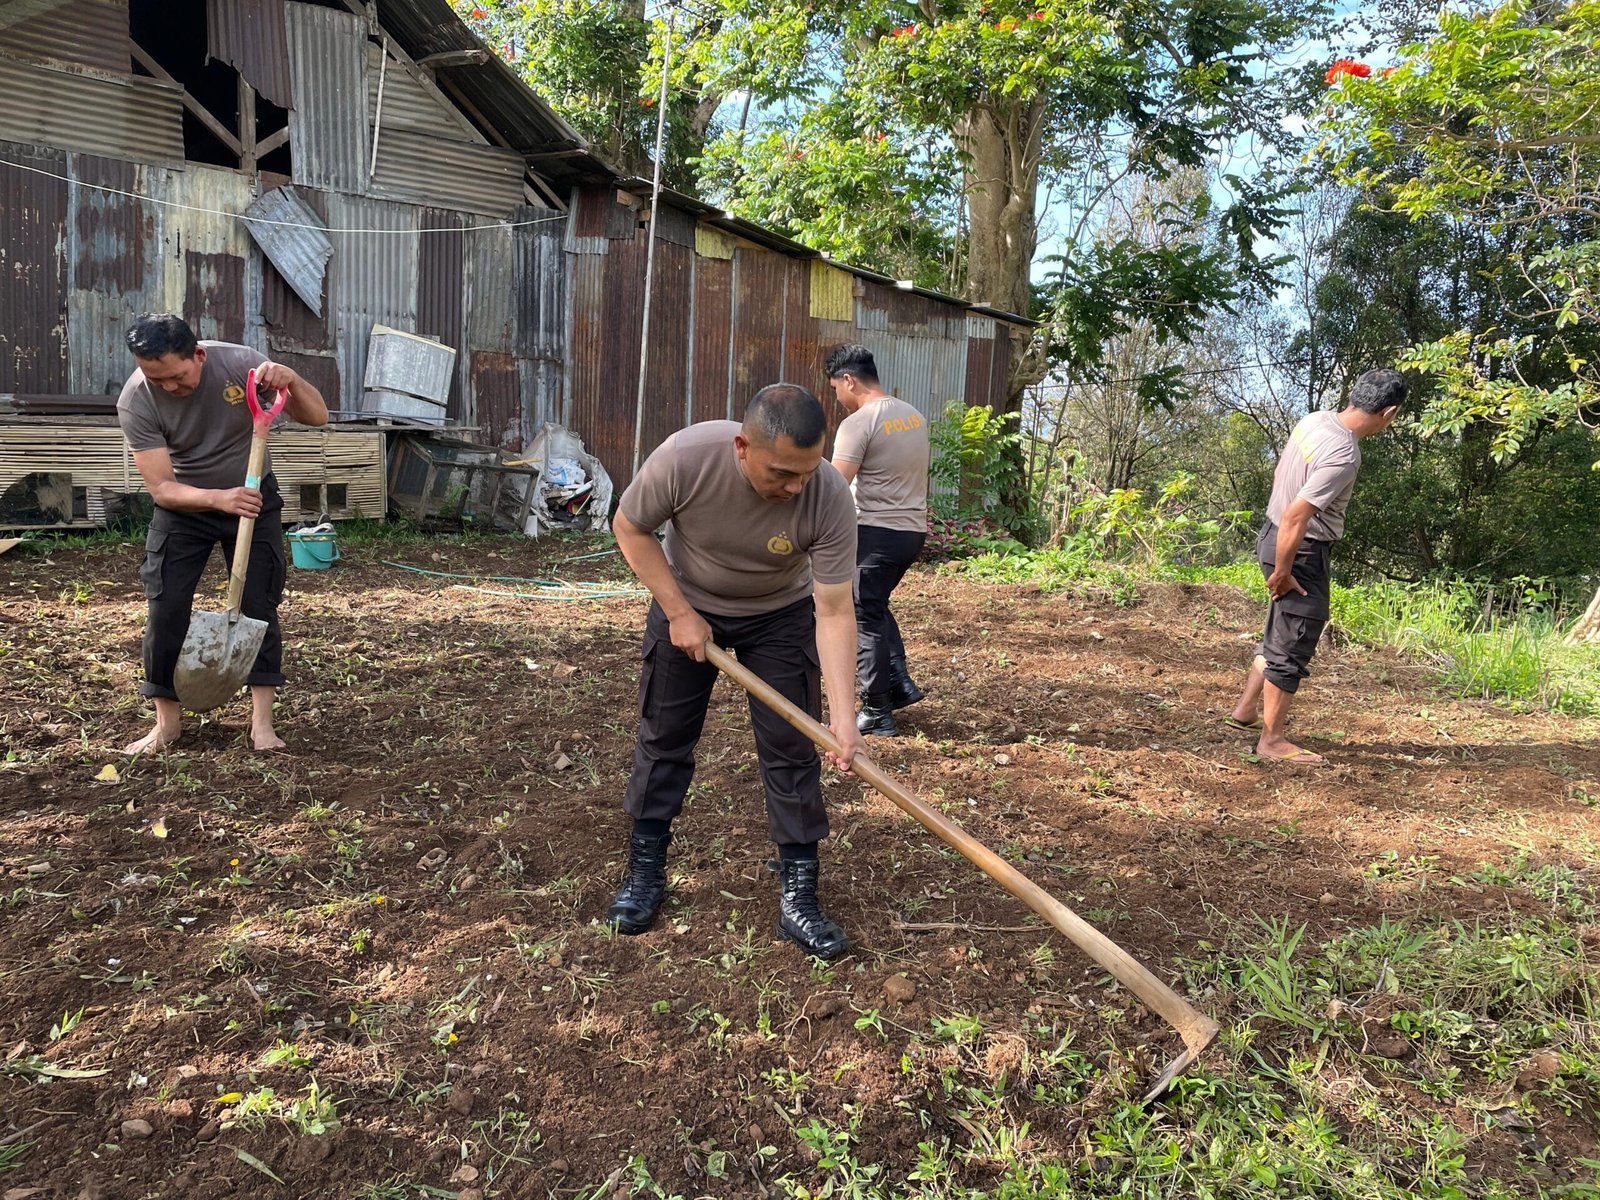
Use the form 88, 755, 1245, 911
706, 642, 1218, 1104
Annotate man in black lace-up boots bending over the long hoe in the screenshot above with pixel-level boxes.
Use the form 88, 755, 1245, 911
606, 384, 861, 958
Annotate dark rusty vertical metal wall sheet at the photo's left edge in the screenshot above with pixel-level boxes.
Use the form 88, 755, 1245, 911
0, 144, 70, 394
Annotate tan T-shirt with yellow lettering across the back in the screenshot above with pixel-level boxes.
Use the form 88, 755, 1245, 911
834, 395, 928, 533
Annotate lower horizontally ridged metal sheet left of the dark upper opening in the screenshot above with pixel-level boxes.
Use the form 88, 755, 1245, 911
0, 54, 184, 165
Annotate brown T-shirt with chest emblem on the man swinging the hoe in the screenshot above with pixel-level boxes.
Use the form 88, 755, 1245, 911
619, 421, 856, 616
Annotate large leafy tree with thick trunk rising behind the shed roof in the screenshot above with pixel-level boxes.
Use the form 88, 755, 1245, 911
682, 0, 1322, 408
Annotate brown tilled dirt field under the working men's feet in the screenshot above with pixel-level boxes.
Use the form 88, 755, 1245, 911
0, 538, 1600, 1200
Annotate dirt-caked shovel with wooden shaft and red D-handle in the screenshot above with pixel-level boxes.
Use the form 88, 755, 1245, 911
173, 371, 288, 712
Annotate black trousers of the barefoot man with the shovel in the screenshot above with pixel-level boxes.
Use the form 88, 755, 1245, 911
139, 475, 288, 699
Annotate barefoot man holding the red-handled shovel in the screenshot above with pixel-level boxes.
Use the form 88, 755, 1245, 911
117, 314, 328, 754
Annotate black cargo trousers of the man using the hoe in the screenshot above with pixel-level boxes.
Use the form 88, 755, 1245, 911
622, 597, 827, 845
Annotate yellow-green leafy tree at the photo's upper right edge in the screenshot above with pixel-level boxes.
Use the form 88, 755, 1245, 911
1323, 0, 1600, 461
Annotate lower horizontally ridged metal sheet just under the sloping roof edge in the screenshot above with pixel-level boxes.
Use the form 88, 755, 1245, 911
362, 130, 526, 218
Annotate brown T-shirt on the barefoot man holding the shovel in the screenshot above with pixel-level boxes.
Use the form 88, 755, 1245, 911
117, 342, 274, 488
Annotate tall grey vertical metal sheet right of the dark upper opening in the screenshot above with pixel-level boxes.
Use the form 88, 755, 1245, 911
285, 0, 371, 192
